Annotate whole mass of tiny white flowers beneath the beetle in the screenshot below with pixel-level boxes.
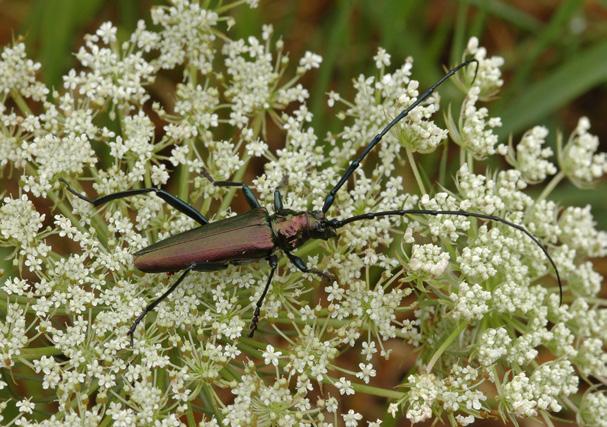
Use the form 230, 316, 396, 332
0, 0, 607, 427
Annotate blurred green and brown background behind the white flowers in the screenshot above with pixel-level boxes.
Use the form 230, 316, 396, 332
0, 0, 607, 228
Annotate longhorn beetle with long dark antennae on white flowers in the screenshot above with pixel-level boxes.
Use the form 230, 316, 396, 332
62, 59, 563, 346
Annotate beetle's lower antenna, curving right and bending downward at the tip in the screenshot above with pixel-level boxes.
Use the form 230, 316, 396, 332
329, 209, 563, 304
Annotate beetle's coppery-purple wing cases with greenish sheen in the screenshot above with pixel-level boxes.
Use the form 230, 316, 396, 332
134, 208, 275, 273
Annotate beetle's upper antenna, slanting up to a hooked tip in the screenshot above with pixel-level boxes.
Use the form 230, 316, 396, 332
322, 58, 479, 213
